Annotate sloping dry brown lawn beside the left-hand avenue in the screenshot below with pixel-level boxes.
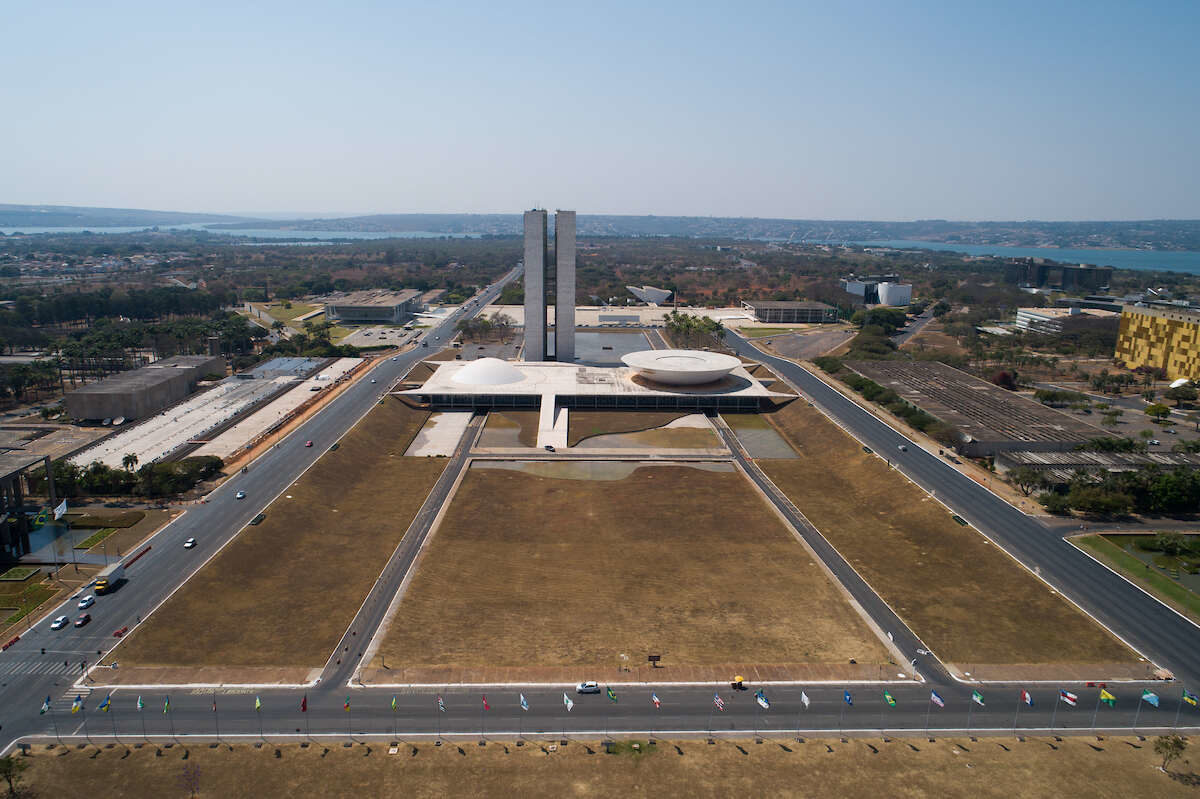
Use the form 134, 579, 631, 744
106, 400, 446, 672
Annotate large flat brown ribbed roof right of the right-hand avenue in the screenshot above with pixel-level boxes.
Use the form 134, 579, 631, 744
846, 361, 1109, 444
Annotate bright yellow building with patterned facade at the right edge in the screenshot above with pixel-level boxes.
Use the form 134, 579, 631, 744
1115, 305, 1200, 380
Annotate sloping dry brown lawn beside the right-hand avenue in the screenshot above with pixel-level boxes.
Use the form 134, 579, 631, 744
758, 402, 1136, 665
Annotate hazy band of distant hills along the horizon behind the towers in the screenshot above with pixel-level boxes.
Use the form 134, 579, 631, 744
0, 204, 1200, 251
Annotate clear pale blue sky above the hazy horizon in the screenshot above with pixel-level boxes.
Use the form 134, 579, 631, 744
0, 0, 1200, 220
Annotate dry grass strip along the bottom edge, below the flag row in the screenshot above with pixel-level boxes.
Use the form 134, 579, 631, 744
24, 738, 1200, 799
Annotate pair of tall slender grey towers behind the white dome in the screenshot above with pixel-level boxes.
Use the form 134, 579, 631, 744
524, 210, 575, 364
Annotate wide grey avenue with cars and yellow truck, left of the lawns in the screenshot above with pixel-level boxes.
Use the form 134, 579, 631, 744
0, 269, 520, 740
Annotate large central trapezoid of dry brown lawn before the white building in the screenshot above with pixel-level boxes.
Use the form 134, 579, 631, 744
377, 462, 887, 679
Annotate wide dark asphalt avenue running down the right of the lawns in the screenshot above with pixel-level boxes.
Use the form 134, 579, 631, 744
726, 332, 1200, 687
